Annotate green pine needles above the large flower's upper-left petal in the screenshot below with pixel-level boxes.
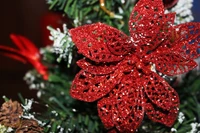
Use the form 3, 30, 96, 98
49, 0, 134, 33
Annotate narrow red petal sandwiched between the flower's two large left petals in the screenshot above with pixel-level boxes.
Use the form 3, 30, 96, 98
77, 59, 117, 75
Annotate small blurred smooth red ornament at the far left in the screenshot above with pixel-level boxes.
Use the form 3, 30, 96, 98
0, 34, 48, 80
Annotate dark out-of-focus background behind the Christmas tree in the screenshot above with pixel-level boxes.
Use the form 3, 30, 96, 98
0, 0, 200, 102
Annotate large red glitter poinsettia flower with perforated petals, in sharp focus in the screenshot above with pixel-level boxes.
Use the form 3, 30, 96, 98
70, 0, 200, 132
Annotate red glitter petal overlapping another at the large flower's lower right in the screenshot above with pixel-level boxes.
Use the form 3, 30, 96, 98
144, 72, 179, 111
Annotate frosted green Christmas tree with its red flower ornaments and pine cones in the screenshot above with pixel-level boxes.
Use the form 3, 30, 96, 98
0, 0, 200, 133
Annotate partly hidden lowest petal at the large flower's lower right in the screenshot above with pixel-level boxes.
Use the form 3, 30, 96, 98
145, 102, 179, 127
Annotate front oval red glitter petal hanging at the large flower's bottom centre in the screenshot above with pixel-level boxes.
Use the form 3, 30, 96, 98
112, 77, 144, 133
